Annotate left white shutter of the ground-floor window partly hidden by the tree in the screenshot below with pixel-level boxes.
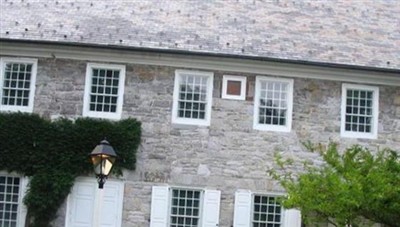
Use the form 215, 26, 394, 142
233, 191, 252, 227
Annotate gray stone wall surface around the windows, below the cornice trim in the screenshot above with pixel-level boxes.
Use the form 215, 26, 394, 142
1, 55, 400, 227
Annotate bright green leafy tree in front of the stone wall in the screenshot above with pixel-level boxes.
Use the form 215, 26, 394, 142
269, 143, 400, 227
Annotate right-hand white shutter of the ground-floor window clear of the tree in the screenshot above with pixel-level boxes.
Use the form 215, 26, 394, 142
202, 190, 221, 227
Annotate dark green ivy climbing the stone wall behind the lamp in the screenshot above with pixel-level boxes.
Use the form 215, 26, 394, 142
0, 113, 141, 227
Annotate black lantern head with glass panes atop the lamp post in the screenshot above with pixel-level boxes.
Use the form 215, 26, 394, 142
90, 140, 117, 189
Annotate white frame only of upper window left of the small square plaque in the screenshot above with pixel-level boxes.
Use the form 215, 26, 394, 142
172, 70, 214, 126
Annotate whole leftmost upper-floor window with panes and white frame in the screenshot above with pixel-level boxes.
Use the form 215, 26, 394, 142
0, 58, 37, 112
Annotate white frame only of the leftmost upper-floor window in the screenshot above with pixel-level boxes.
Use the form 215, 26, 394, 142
0, 58, 38, 113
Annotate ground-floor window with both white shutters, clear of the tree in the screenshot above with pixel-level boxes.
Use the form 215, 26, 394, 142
150, 186, 221, 227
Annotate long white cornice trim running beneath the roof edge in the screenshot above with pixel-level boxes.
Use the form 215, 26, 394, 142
0, 42, 400, 86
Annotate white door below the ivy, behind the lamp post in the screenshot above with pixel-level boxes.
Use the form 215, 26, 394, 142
65, 178, 124, 227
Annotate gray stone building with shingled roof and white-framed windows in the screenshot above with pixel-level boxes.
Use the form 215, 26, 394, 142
0, 0, 400, 227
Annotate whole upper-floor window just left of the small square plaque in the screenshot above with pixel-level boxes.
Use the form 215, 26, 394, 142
172, 70, 214, 125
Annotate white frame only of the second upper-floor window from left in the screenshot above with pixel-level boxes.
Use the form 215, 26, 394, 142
82, 63, 126, 120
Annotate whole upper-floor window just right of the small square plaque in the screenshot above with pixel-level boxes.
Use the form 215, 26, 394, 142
253, 77, 293, 132
